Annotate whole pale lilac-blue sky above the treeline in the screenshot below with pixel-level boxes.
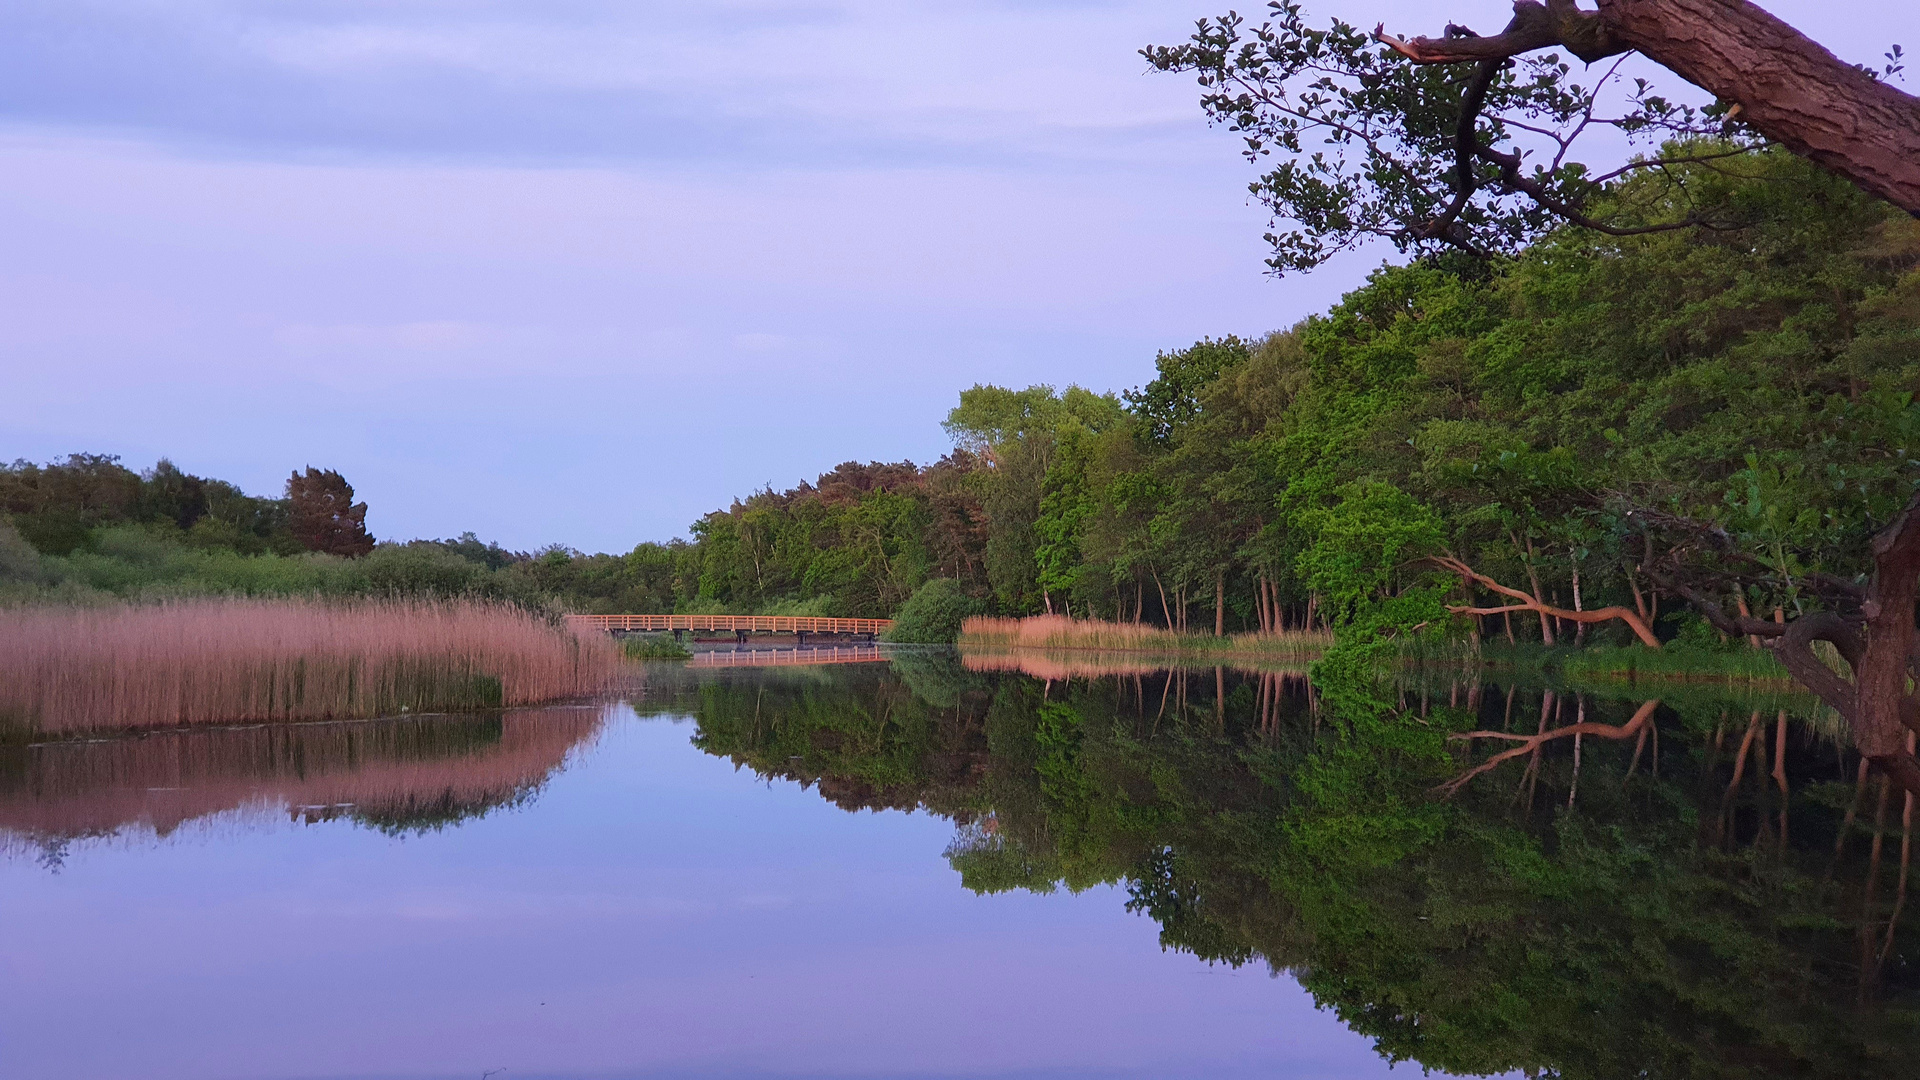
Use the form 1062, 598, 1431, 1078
0, 0, 1920, 552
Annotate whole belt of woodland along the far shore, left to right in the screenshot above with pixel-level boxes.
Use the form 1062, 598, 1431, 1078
0, 152, 1920, 644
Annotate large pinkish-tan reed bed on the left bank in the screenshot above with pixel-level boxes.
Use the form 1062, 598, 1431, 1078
0, 598, 620, 738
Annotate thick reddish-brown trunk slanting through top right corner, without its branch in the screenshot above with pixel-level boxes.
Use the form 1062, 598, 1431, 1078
1597, 0, 1920, 215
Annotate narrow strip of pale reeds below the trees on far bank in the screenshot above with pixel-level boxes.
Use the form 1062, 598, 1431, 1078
958, 615, 1332, 663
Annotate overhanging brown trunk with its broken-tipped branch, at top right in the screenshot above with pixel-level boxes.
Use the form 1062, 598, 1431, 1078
1375, 0, 1920, 215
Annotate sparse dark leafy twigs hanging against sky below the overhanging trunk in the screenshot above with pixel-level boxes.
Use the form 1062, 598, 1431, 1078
1142, 0, 1763, 273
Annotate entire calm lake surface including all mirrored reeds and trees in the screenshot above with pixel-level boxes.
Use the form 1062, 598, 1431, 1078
0, 655, 1920, 1080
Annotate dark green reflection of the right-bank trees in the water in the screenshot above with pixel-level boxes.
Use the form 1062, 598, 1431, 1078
693, 671, 1920, 1080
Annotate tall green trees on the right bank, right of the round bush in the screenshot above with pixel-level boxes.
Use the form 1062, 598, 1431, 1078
954, 146, 1920, 667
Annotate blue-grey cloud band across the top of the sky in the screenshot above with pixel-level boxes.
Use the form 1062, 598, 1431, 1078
0, 0, 1192, 167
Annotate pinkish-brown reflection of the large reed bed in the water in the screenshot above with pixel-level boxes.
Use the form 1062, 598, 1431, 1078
0, 709, 601, 849
